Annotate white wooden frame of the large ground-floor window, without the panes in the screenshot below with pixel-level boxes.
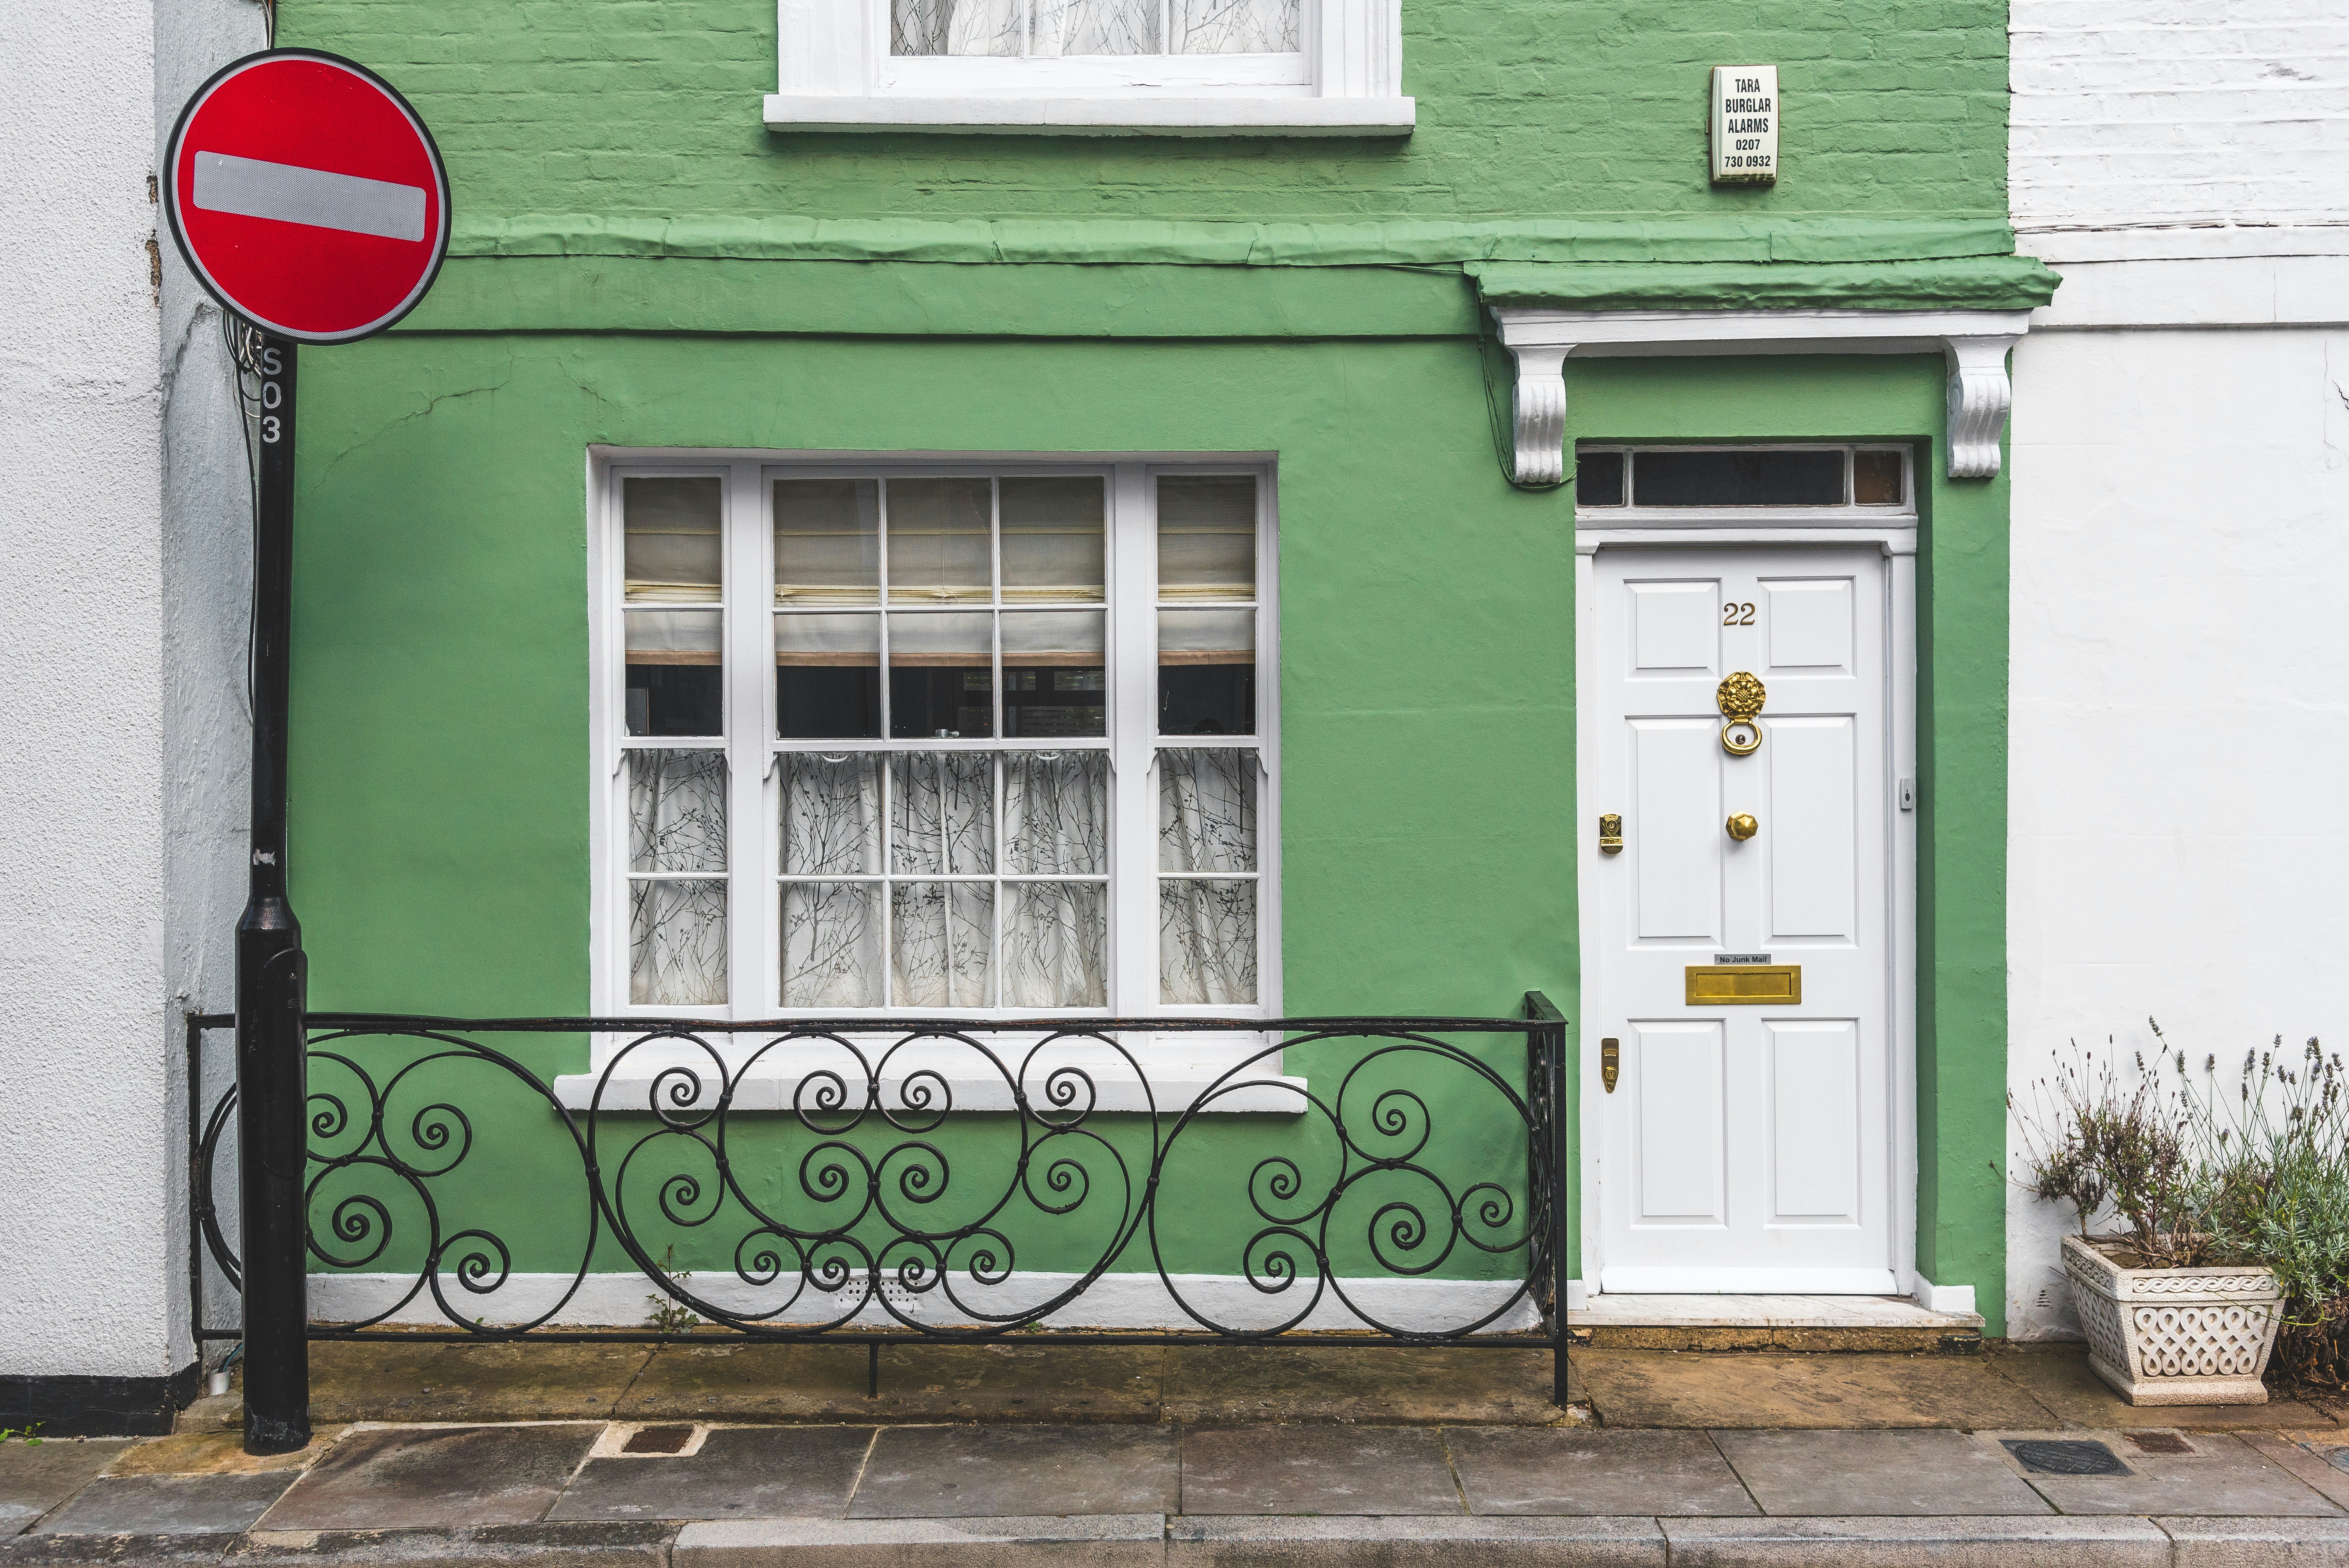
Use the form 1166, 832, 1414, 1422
583, 448, 1297, 1066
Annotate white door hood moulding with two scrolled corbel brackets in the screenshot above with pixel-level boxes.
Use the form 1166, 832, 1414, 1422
1492, 305, 2030, 483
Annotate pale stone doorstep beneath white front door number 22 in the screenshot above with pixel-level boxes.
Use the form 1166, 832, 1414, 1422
1567, 1296, 1983, 1354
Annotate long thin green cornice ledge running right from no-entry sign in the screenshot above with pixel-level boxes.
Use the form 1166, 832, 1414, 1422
449, 214, 2016, 267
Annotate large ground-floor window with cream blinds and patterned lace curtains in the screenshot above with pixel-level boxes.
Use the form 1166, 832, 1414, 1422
597, 460, 1276, 1016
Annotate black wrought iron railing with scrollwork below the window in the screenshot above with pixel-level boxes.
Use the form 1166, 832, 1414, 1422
188, 993, 1569, 1401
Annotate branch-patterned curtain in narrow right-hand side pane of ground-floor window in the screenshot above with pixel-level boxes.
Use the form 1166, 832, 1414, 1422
1158, 749, 1257, 1007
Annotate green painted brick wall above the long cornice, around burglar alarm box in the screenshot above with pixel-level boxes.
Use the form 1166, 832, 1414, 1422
280, 0, 2006, 223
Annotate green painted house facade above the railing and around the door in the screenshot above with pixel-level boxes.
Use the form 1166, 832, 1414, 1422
280, 0, 2051, 1331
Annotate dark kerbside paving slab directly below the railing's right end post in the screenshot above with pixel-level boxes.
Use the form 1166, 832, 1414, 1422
1445, 1427, 1762, 1516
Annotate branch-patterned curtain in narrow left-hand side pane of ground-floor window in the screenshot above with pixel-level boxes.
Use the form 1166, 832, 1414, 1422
627, 751, 726, 1007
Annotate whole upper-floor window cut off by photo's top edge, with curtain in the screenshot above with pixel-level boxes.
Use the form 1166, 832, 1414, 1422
766, 0, 1414, 136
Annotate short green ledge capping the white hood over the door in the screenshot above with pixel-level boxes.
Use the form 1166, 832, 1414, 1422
1463, 256, 2060, 310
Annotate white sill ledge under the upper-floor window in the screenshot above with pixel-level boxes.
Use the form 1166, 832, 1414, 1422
766, 94, 1417, 136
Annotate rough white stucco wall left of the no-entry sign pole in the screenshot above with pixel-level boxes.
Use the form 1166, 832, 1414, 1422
0, 0, 261, 1378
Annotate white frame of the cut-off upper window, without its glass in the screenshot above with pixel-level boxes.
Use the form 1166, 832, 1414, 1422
766, 0, 1417, 136
